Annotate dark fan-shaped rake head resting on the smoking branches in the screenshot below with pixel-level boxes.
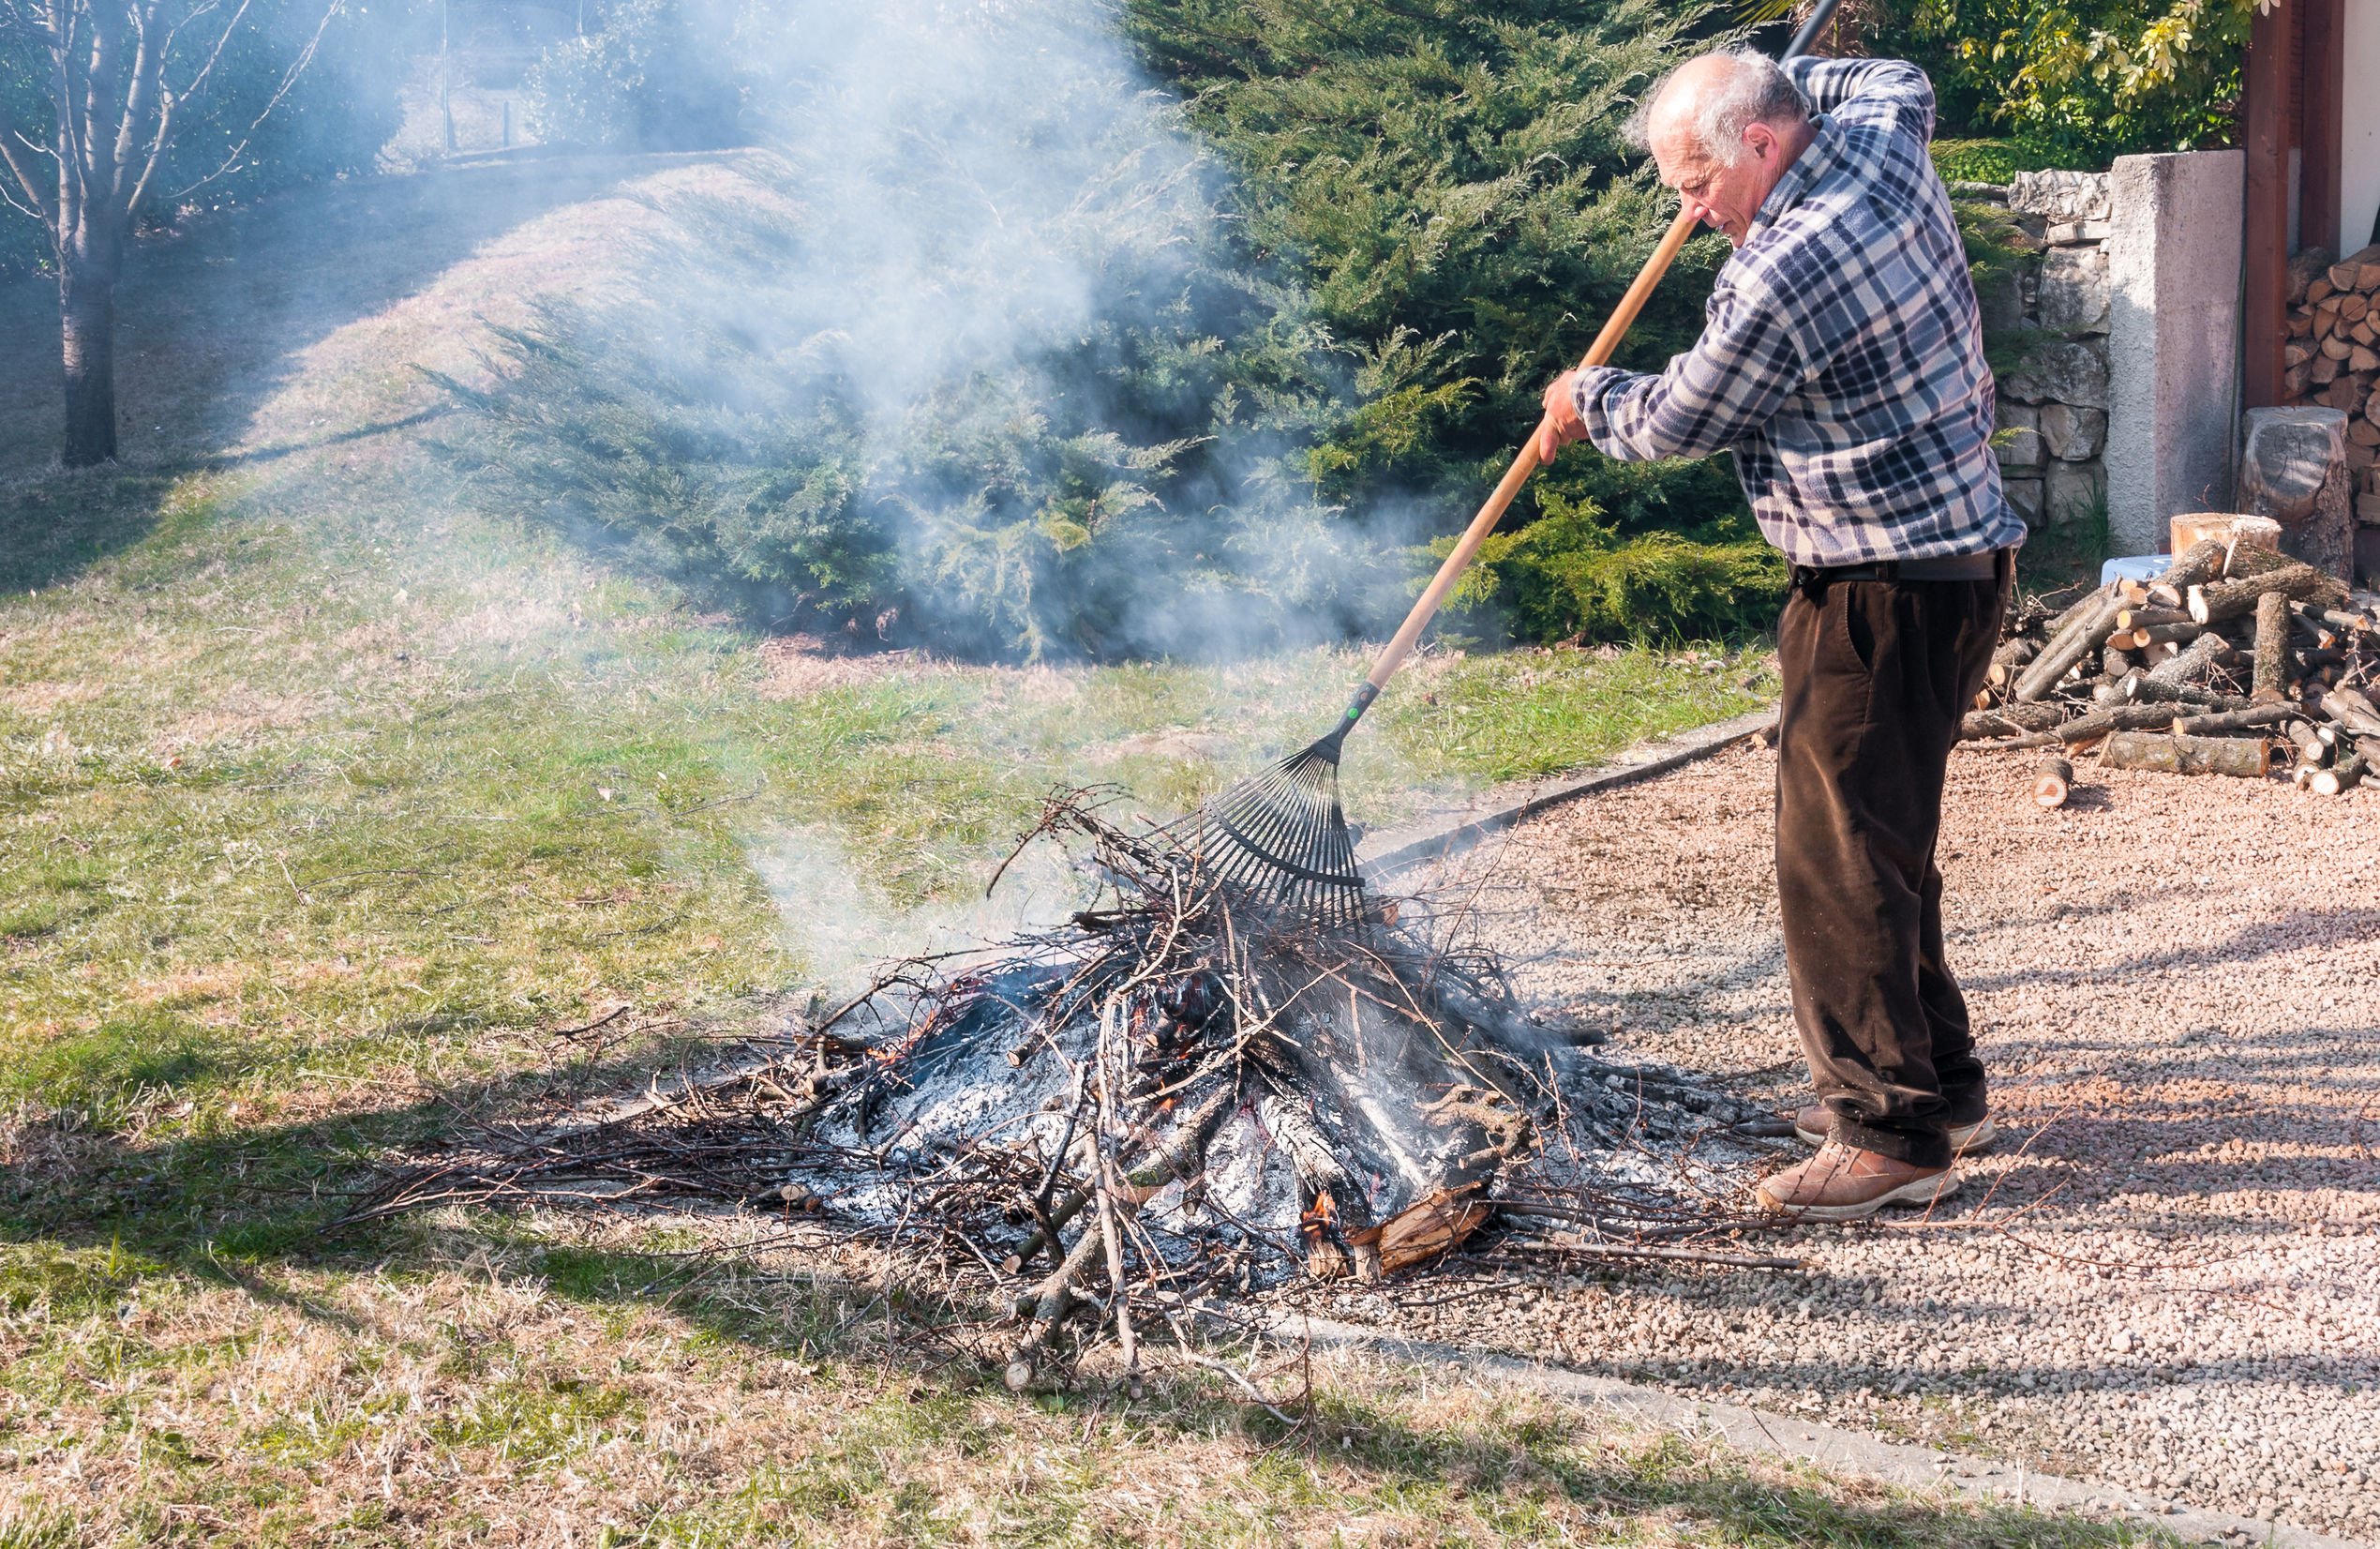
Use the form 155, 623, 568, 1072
1174, 726, 1370, 930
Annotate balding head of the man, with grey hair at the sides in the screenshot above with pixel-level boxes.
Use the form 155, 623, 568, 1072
1628, 48, 1816, 248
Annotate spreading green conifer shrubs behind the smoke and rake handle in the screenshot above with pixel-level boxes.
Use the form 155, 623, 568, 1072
447, 0, 1808, 656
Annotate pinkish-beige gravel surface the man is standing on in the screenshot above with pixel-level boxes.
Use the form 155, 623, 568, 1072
1316, 747, 2380, 1540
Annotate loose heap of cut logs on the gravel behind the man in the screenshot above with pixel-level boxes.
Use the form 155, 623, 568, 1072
1964, 538, 2380, 806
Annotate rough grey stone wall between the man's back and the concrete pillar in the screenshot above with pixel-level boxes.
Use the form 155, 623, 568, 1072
1956, 172, 2114, 526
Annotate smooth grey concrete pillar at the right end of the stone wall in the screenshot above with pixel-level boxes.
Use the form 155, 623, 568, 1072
2106, 150, 2242, 554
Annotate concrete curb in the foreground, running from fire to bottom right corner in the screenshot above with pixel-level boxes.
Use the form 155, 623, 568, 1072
1268, 1314, 2373, 1549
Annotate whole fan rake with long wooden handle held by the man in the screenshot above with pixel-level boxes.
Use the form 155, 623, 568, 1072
1169, 0, 1837, 930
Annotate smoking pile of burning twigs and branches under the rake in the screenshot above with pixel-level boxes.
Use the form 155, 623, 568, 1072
350, 792, 1797, 1387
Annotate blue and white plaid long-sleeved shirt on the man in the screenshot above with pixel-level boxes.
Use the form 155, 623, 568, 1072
1578, 59, 2026, 566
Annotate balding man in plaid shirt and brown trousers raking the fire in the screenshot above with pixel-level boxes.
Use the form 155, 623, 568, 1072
1540, 53, 2026, 1221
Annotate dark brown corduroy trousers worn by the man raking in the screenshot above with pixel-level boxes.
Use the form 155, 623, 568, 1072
1778, 554, 2013, 1166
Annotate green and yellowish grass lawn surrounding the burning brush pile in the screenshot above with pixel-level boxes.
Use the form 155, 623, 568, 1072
0, 159, 2161, 1546
